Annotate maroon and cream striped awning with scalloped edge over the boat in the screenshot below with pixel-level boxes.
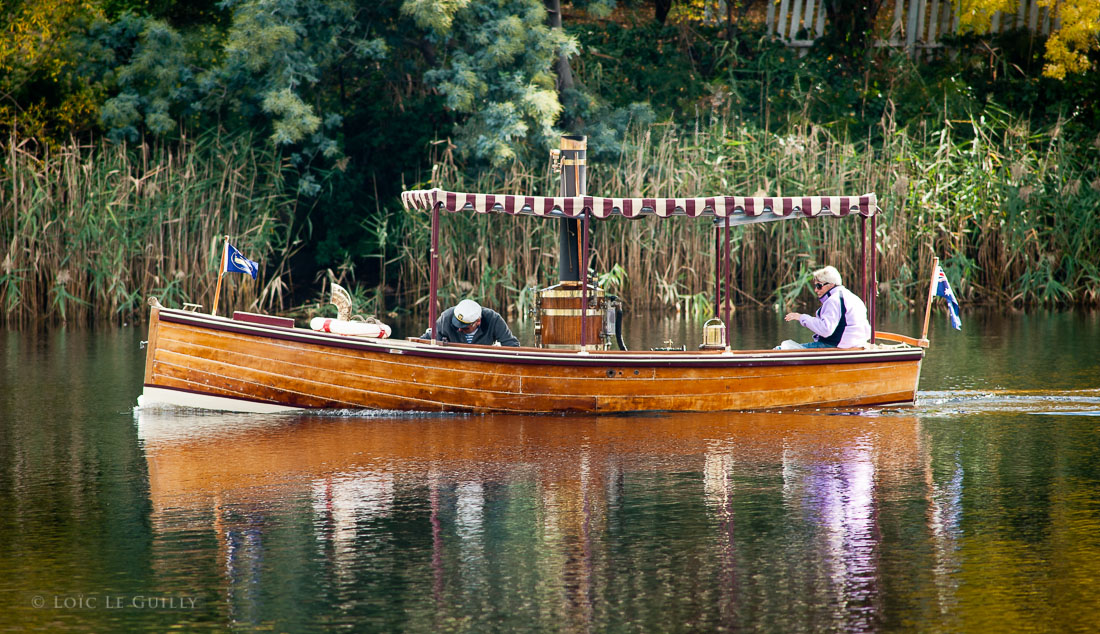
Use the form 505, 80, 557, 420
402, 188, 879, 225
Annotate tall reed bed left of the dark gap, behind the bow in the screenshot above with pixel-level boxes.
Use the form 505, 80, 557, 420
0, 132, 294, 324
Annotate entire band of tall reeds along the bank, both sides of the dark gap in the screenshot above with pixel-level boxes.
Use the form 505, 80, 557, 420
0, 112, 1100, 324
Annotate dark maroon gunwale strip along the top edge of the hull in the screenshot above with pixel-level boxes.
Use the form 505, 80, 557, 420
151, 308, 924, 368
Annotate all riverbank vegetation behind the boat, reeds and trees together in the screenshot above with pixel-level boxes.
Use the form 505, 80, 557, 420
0, 0, 1100, 324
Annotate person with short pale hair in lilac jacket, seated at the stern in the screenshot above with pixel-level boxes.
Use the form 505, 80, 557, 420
782, 266, 871, 348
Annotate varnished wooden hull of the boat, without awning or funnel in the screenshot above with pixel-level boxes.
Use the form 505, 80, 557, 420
141, 307, 924, 414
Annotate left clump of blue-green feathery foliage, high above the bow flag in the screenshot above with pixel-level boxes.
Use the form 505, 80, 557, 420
80, 0, 386, 178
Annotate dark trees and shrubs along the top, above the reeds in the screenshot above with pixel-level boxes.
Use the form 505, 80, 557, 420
8, 0, 1100, 308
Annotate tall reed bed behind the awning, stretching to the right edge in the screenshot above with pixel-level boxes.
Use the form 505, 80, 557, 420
399, 114, 1100, 313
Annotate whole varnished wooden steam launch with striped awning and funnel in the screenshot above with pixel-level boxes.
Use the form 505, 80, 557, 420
140, 138, 926, 414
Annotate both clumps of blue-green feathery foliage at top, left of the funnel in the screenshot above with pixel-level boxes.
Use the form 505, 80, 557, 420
63, 0, 578, 171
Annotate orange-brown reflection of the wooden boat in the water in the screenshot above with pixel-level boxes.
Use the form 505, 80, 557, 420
136, 411, 960, 630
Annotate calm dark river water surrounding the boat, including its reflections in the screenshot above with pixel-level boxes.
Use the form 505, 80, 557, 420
0, 311, 1100, 633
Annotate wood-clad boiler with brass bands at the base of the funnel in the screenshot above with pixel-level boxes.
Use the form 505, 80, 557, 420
535, 282, 614, 350
